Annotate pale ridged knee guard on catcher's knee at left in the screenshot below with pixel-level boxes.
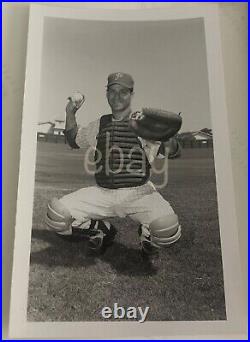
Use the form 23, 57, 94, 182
45, 198, 73, 233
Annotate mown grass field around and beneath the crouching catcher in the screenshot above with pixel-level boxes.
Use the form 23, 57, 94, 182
28, 142, 226, 321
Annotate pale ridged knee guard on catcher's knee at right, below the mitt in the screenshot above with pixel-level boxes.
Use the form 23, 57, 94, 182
149, 214, 181, 247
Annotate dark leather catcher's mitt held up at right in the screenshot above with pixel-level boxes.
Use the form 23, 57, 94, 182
129, 108, 182, 141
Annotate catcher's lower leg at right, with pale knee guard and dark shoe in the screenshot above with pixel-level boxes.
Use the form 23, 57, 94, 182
138, 214, 181, 257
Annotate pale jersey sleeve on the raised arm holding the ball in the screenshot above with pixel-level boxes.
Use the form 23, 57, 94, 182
76, 119, 100, 148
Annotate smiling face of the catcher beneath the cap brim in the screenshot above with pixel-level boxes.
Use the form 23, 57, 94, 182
107, 84, 133, 112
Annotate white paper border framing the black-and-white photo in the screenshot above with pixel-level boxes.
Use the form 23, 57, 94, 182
9, 3, 246, 339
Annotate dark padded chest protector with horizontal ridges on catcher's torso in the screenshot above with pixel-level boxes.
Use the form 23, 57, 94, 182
95, 114, 150, 189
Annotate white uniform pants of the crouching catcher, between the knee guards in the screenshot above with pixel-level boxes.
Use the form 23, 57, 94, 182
60, 182, 174, 225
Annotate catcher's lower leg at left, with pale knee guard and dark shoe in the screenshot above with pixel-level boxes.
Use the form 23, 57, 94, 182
45, 198, 117, 252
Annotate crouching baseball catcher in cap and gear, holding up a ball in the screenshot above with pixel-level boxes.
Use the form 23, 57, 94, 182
46, 72, 181, 256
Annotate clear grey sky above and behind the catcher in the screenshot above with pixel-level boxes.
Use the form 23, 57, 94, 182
39, 18, 211, 132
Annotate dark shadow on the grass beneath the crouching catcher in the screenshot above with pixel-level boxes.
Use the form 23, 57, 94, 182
30, 229, 157, 276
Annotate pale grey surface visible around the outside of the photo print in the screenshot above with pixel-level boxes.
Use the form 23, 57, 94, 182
3, 3, 247, 338
